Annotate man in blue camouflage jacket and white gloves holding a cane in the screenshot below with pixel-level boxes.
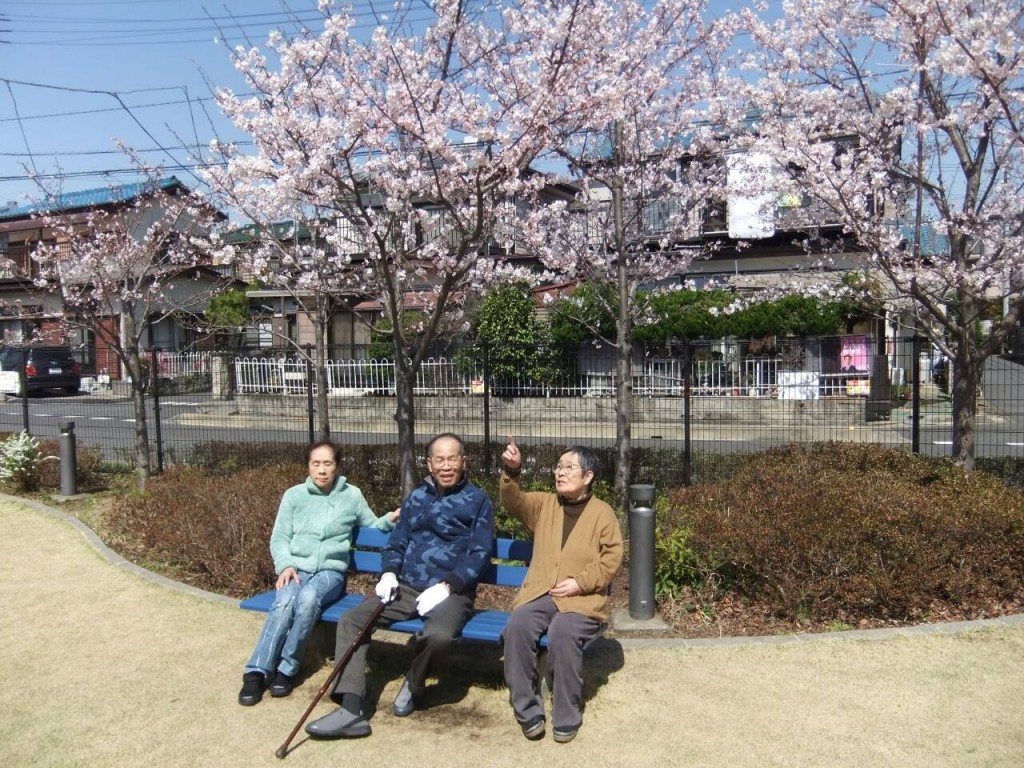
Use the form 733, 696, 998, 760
306, 432, 495, 738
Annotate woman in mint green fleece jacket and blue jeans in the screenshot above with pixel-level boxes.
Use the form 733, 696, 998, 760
239, 440, 398, 707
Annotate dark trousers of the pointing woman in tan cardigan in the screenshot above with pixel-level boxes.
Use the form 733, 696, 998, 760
502, 595, 601, 728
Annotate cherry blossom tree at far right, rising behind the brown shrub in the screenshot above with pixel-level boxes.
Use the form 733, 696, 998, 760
738, 0, 1024, 468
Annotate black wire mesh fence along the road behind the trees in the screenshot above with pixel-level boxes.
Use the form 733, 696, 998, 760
0, 336, 1024, 484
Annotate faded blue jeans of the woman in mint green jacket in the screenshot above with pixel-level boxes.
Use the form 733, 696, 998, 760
246, 570, 345, 677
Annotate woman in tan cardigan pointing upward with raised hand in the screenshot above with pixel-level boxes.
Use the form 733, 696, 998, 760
501, 437, 623, 743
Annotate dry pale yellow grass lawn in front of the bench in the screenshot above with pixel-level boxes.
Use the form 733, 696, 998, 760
0, 500, 1024, 768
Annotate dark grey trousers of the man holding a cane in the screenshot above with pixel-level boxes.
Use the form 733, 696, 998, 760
332, 584, 473, 698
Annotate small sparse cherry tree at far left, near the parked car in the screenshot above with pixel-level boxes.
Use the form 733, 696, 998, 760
33, 172, 225, 488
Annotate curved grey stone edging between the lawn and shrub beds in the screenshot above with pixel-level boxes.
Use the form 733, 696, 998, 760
9, 494, 1024, 648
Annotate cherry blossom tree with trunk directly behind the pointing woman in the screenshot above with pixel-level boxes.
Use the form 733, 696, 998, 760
526, 0, 730, 505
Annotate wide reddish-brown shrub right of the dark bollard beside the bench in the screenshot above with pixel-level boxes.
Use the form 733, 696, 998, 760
669, 443, 1024, 621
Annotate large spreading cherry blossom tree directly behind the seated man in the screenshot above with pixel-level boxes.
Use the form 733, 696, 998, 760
209, 0, 622, 489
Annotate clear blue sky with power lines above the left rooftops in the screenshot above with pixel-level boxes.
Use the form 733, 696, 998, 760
0, 0, 423, 205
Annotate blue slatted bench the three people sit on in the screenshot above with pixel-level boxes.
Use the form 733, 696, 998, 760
241, 528, 548, 647
